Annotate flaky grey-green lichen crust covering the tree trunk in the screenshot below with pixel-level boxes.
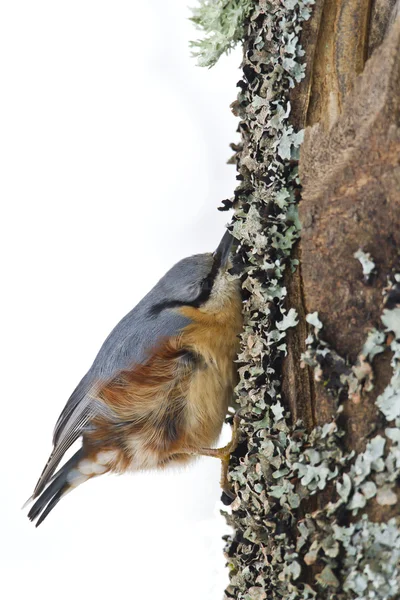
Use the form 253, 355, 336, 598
190, 0, 400, 600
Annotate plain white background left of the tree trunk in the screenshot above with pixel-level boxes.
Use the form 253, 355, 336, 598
0, 0, 240, 600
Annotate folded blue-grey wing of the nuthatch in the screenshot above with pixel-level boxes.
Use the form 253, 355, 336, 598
33, 301, 190, 497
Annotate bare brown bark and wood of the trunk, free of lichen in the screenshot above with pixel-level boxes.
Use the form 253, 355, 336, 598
283, 0, 400, 464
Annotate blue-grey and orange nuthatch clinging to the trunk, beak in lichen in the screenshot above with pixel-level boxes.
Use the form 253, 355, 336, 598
28, 231, 242, 525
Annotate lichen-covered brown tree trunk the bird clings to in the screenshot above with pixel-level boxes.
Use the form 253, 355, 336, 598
217, 0, 400, 600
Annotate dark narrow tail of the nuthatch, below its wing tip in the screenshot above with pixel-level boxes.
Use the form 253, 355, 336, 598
28, 448, 88, 527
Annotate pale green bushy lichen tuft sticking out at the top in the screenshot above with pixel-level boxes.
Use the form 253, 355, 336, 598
190, 0, 254, 67
